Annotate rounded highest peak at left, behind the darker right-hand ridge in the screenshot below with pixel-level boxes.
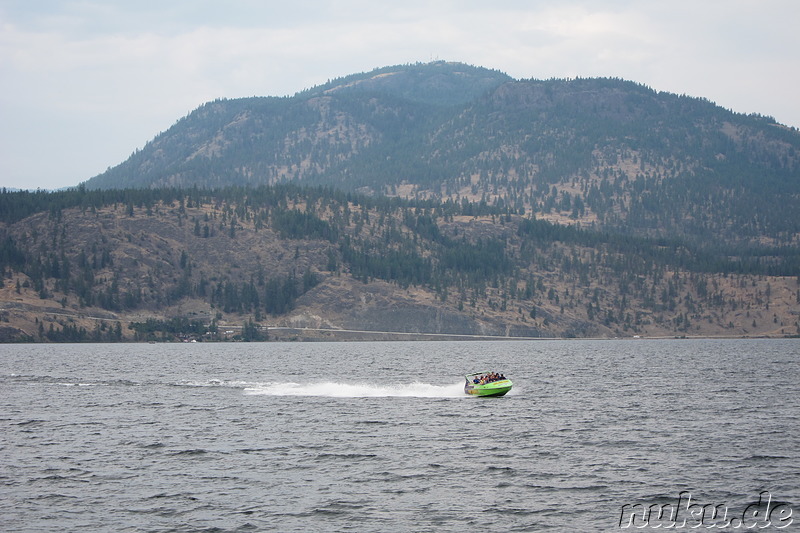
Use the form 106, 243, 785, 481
86, 62, 511, 189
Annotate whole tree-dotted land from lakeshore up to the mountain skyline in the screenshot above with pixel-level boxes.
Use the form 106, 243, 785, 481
0, 62, 800, 341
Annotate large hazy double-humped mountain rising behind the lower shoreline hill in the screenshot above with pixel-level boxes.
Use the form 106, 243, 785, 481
85, 62, 800, 249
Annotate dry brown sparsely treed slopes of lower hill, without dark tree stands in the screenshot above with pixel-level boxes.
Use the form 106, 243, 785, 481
0, 193, 800, 341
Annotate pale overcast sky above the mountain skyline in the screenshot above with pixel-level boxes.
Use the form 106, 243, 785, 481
0, 0, 800, 189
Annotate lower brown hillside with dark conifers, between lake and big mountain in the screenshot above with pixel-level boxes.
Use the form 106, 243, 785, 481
0, 185, 800, 341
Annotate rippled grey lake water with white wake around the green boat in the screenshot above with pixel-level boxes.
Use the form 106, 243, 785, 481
0, 340, 800, 532
